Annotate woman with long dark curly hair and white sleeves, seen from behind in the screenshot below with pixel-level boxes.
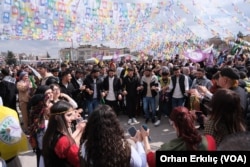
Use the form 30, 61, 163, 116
79, 105, 146, 167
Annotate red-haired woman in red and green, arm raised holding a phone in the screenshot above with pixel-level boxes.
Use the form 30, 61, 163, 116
140, 106, 216, 167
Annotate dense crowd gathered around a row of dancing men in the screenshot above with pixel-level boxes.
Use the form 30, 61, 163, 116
0, 53, 250, 167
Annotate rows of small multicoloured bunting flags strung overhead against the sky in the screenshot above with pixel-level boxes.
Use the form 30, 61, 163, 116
0, 0, 250, 57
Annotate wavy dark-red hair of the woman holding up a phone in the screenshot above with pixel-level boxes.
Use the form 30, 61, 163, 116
170, 106, 202, 150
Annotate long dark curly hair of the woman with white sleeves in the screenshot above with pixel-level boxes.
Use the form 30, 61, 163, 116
82, 105, 131, 167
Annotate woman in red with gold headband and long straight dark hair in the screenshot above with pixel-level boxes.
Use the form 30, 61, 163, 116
42, 100, 86, 167
